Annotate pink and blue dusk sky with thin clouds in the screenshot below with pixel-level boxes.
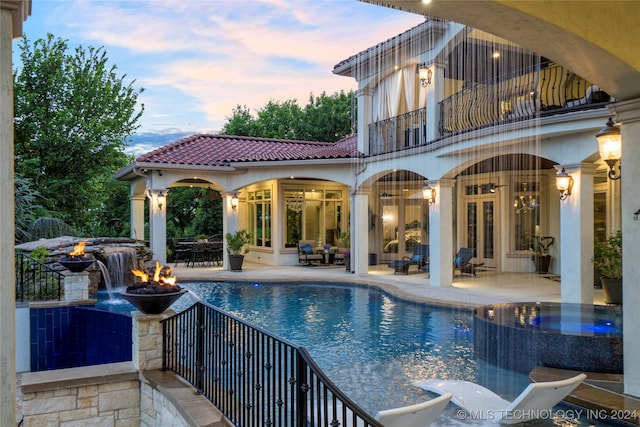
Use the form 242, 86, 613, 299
14, 0, 424, 132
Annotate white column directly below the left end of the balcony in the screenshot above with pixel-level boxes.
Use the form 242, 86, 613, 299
351, 189, 369, 274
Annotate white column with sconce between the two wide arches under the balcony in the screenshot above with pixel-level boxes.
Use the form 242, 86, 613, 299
429, 179, 455, 287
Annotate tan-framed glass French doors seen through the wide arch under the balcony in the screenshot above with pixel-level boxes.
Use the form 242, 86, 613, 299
464, 195, 497, 268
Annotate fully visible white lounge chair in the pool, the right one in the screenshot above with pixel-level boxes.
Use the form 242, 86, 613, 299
413, 374, 587, 424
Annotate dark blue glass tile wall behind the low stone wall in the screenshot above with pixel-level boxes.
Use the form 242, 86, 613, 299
30, 306, 132, 372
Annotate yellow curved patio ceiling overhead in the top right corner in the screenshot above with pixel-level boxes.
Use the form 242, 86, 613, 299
361, 0, 640, 101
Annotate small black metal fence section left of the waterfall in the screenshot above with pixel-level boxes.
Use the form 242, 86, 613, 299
15, 252, 64, 302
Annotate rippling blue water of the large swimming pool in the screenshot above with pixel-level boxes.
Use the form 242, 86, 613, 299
98, 282, 598, 426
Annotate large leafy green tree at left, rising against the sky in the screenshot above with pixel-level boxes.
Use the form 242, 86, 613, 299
14, 34, 144, 233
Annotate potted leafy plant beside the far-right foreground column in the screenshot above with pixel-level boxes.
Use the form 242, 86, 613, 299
593, 231, 622, 304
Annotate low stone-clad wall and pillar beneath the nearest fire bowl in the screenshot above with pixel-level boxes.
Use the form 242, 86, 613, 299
21, 311, 230, 427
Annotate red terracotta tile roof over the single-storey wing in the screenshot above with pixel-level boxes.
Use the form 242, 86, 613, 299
136, 134, 358, 166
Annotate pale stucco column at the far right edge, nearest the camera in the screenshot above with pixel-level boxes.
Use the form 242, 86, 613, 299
610, 99, 640, 396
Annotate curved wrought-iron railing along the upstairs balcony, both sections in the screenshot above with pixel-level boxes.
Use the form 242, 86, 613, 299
369, 62, 611, 155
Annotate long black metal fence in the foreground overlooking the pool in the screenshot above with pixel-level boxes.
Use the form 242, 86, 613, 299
162, 302, 382, 427
